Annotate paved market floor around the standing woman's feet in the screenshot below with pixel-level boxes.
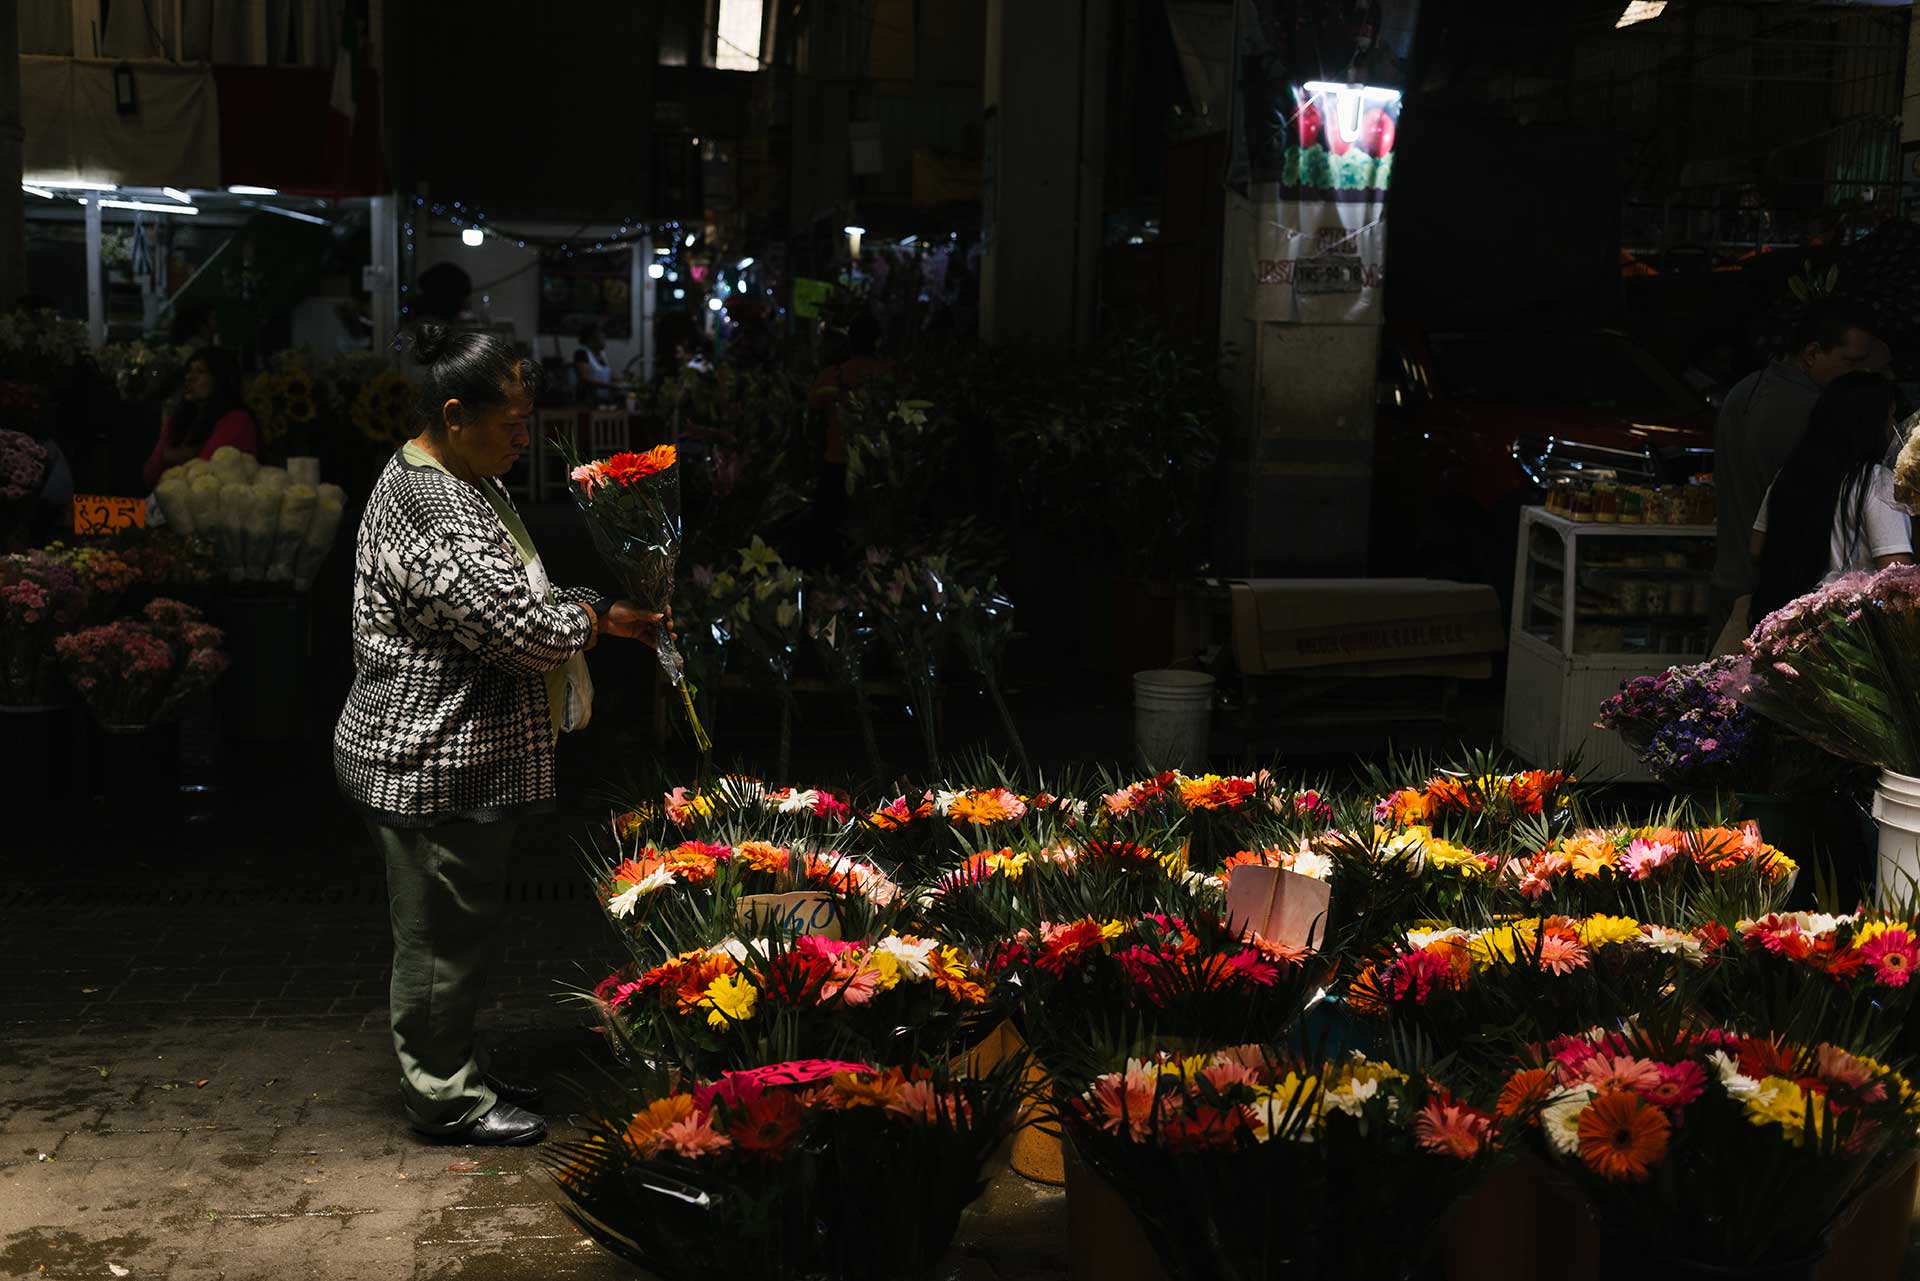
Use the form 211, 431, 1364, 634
0, 855, 1066, 1281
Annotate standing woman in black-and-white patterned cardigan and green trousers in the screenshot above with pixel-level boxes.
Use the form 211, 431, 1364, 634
334, 325, 660, 1145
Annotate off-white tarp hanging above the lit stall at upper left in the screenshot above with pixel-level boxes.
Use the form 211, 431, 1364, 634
19, 58, 221, 188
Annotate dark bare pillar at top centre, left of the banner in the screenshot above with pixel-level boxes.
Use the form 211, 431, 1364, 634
979, 0, 1112, 348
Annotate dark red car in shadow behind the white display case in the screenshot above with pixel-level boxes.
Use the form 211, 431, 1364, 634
1373, 325, 1713, 597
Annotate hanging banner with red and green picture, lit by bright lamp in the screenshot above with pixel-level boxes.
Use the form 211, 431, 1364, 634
1235, 0, 1419, 325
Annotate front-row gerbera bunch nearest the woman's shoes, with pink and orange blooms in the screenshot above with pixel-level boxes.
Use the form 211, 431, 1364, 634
547, 1060, 1023, 1281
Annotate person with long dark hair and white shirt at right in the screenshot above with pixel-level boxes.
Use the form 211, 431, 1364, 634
1749, 371, 1914, 620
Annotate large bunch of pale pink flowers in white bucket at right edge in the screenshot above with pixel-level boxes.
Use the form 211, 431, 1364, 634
1740, 565, 1920, 774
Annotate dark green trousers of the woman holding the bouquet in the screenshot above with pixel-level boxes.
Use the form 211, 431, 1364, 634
367, 820, 515, 1133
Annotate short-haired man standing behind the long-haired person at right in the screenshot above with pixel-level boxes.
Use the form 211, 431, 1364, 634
1713, 298, 1885, 634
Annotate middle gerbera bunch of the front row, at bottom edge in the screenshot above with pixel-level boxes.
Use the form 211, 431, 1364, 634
1060, 1047, 1500, 1281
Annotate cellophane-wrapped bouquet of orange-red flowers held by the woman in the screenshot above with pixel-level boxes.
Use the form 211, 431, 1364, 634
561, 440, 712, 751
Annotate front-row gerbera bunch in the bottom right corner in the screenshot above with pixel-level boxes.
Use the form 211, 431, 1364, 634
1501, 1027, 1916, 1281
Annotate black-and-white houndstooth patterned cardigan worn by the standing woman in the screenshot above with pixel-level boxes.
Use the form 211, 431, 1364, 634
334, 453, 595, 828
